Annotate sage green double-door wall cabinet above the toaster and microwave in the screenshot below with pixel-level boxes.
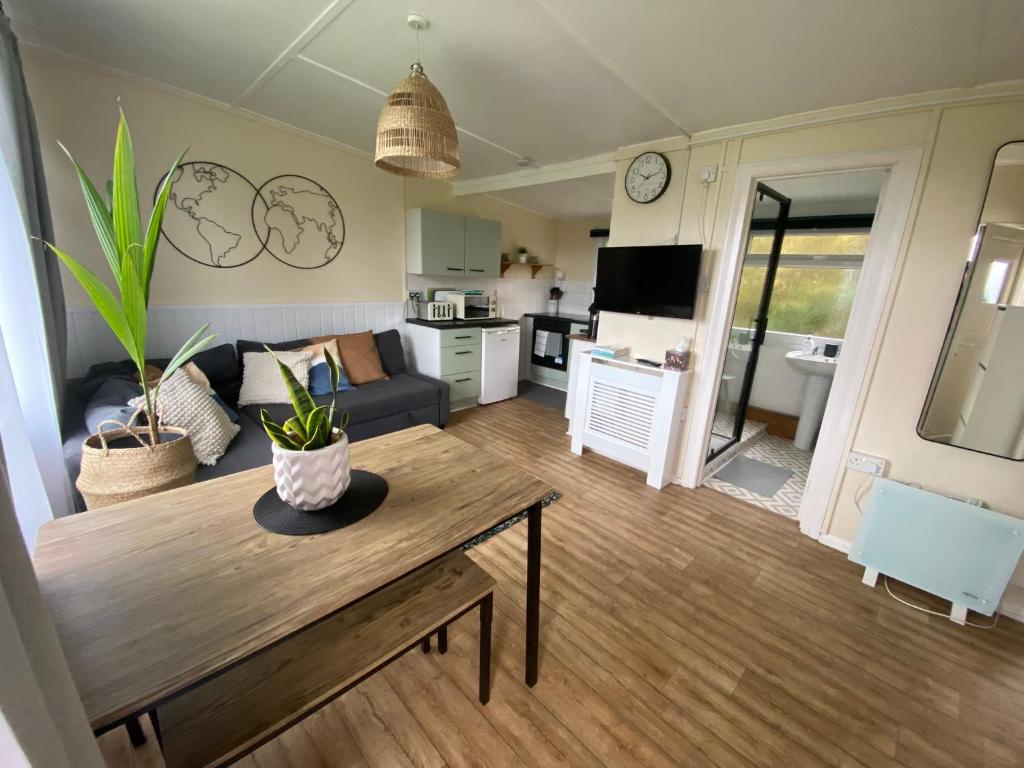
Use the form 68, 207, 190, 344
406, 208, 502, 278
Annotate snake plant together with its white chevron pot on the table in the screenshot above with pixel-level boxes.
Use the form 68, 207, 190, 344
260, 347, 352, 512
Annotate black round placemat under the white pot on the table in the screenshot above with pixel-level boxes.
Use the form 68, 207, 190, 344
253, 469, 388, 536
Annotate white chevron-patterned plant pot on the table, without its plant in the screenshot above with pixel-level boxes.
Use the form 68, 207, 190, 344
271, 434, 352, 512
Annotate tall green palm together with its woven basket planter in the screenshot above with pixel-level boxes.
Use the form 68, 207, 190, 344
46, 112, 214, 509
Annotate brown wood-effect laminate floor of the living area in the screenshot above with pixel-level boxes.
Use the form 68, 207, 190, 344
100, 398, 1024, 768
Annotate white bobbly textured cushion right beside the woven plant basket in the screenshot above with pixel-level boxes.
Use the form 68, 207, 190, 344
132, 369, 241, 466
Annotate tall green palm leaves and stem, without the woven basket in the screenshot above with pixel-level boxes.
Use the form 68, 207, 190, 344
46, 111, 214, 445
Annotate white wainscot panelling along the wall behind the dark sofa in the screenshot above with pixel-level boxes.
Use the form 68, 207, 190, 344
68, 301, 406, 377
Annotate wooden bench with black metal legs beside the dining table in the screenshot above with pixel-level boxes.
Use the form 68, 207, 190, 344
154, 552, 495, 768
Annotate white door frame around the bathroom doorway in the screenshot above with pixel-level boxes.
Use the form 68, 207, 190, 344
680, 147, 923, 539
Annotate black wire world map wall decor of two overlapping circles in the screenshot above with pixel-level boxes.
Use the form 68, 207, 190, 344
157, 161, 345, 269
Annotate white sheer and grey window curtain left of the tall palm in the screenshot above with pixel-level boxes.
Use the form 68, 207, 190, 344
0, 13, 73, 551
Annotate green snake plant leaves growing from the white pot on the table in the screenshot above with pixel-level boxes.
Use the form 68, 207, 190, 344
259, 345, 348, 451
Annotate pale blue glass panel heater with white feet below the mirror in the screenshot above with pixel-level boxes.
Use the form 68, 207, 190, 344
850, 478, 1024, 624
